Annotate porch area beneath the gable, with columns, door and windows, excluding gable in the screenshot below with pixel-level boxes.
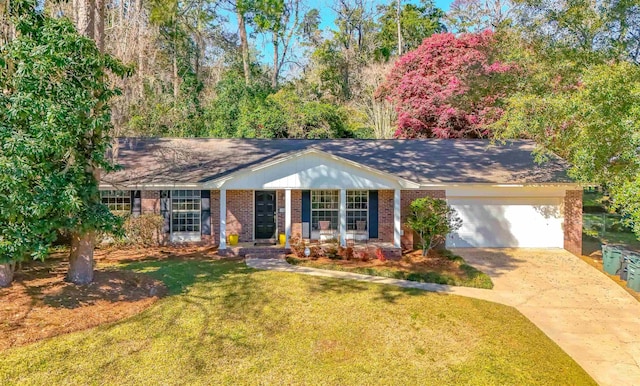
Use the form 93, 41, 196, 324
218, 189, 402, 249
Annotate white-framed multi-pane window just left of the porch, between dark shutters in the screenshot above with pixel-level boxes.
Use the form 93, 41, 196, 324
171, 190, 202, 233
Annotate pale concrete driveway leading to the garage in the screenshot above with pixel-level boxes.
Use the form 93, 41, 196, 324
454, 248, 640, 385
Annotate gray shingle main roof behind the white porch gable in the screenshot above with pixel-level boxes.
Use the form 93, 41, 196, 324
102, 138, 571, 186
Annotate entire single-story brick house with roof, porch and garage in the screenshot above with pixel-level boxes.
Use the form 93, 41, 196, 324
100, 138, 582, 254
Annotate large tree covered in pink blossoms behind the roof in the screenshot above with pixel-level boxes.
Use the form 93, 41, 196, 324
377, 31, 516, 138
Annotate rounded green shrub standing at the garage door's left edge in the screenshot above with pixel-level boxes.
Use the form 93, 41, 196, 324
407, 197, 462, 256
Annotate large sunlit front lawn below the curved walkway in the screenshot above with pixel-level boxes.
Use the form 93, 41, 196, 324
0, 260, 594, 385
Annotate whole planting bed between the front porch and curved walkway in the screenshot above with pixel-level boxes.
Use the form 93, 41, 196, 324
287, 250, 493, 289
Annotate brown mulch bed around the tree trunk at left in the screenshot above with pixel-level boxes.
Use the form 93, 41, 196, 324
0, 250, 180, 351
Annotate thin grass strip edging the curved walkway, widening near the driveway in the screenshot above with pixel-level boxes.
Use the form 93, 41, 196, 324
287, 251, 493, 289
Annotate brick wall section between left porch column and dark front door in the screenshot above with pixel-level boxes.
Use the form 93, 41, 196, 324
227, 190, 254, 241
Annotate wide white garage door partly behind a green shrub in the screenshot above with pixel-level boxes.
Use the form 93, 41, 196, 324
447, 197, 564, 248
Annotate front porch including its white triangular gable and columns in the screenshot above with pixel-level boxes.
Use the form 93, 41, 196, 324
208, 150, 419, 250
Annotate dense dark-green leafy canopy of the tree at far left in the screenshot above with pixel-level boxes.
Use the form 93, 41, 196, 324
0, 1, 127, 284
